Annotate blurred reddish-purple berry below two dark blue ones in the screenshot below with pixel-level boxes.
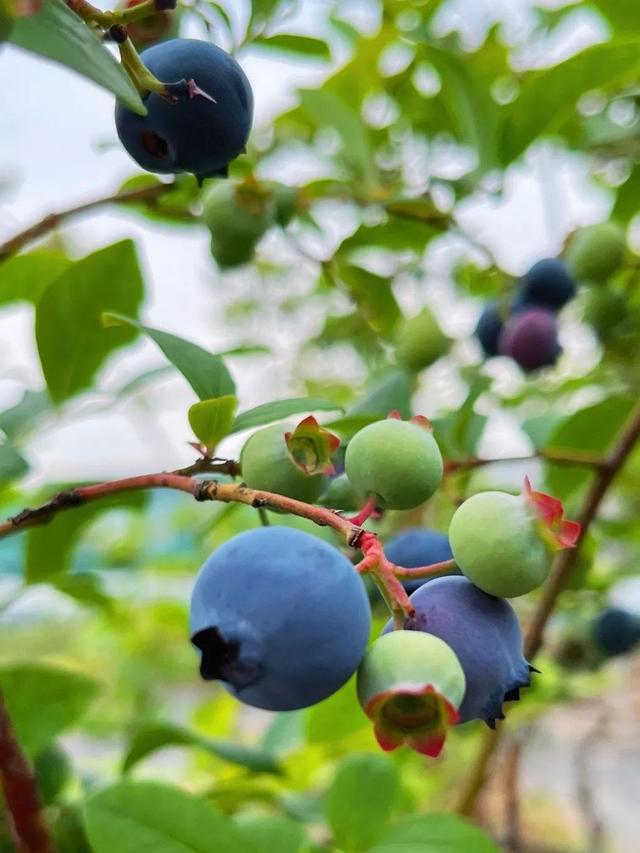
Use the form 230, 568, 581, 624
498, 308, 562, 372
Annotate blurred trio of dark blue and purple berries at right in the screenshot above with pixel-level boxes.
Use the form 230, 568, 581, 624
476, 258, 576, 372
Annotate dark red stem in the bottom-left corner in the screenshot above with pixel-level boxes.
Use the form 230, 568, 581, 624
0, 693, 55, 853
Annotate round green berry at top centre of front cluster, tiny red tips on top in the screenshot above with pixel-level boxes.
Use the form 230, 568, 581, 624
345, 418, 443, 509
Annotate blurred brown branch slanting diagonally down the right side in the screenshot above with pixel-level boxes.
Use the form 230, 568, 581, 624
457, 405, 640, 815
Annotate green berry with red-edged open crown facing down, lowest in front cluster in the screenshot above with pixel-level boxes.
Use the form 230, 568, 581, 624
357, 631, 466, 756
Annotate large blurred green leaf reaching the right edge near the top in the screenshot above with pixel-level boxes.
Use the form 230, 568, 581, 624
499, 36, 640, 165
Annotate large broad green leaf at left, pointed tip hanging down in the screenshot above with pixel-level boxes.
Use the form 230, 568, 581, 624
36, 240, 144, 403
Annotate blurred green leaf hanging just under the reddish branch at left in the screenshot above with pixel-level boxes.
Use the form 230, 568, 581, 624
25, 492, 146, 584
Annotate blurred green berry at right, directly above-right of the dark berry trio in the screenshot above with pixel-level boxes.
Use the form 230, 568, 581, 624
567, 222, 626, 282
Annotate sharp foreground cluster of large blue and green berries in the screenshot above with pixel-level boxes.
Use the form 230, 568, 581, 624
191, 416, 579, 756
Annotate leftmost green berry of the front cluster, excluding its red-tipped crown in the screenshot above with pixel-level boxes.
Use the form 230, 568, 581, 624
240, 424, 326, 503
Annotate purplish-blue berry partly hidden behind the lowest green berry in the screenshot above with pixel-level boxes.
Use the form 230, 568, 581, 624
384, 576, 531, 728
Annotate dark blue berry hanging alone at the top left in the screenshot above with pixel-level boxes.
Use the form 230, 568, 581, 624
116, 39, 253, 180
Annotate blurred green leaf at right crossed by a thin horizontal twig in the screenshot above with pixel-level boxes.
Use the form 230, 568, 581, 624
545, 397, 634, 500
